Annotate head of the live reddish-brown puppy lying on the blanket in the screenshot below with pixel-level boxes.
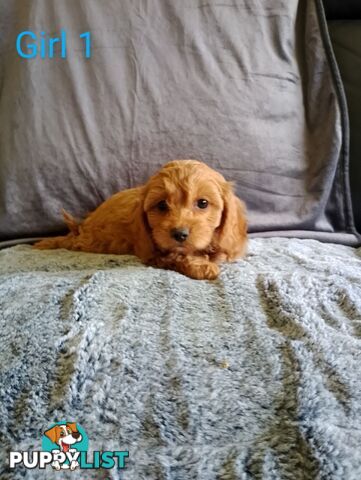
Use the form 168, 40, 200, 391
139, 160, 246, 255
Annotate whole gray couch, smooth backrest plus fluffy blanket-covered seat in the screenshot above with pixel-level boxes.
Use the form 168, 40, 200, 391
0, 0, 361, 480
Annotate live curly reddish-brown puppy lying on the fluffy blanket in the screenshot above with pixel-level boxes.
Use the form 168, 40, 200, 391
35, 160, 247, 280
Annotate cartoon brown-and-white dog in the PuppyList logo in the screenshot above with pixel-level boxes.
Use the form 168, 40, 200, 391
44, 423, 83, 470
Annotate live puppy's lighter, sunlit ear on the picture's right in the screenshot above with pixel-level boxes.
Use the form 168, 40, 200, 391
218, 182, 247, 260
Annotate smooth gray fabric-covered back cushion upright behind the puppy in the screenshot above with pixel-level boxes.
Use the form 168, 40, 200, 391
0, 0, 359, 244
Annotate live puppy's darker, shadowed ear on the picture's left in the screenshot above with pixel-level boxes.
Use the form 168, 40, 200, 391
133, 189, 155, 262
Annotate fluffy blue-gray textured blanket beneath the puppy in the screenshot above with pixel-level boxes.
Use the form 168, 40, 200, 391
0, 239, 361, 480
